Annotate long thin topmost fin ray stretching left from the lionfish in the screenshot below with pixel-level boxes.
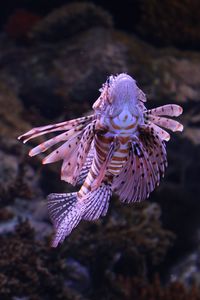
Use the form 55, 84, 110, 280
18, 115, 95, 143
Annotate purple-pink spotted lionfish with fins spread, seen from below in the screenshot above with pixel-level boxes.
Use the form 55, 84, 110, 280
19, 73, 183, 247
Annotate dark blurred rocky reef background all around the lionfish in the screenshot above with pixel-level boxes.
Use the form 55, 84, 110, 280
0, 0, 200, 300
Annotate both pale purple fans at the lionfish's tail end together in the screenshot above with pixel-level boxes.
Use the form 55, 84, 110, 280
48, 183, 112, 247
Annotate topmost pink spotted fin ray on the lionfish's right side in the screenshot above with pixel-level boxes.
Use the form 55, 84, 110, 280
146, 104, 183, 117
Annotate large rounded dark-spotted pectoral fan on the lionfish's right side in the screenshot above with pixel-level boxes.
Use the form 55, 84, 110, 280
112, 128, 167, 203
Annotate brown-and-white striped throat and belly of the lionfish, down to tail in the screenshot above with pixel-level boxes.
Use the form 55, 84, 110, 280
78, 105, 141, 198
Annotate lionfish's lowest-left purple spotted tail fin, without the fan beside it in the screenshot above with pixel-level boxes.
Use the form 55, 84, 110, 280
48, 193, 84, 247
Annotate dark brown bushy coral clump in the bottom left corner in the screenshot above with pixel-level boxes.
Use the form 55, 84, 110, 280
0, 221, 83, 300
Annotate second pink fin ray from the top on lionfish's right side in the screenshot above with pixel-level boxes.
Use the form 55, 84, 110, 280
148, 115, 183, 131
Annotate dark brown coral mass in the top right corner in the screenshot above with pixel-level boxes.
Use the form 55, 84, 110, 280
137, 0, 200, 49
